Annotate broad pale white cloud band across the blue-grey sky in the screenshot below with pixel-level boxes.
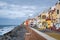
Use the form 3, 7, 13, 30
0, 1, 48, 18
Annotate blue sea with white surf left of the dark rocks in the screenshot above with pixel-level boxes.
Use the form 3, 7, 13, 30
0, 25, 17, 35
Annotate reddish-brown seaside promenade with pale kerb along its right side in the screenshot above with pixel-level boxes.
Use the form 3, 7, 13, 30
25, 27, 56, 40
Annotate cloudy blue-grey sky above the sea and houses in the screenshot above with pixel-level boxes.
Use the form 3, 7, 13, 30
0, 0, 58, 25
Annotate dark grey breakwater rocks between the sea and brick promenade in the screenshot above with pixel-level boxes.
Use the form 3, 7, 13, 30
0, 24, 26, 40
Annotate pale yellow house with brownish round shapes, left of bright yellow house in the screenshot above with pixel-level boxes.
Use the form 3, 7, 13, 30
38, 12, 48, 29
